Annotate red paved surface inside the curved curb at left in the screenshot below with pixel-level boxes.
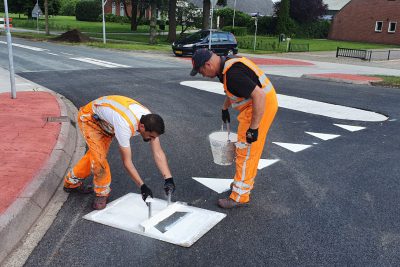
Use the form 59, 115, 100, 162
0, 92, 61, 213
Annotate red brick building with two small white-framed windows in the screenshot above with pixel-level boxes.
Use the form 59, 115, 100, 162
328, 0, 400, 45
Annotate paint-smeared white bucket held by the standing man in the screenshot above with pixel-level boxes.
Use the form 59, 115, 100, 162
208, 131, 237, 166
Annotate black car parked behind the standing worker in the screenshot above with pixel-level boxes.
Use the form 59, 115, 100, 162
172, 30, 238, 56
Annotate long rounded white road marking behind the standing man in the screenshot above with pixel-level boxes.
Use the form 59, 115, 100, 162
180, 81, 387, 121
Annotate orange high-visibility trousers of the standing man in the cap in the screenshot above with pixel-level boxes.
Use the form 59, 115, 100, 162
230, 89, 278, 203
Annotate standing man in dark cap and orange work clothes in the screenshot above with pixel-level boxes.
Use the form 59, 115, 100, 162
190, 49, 278, 209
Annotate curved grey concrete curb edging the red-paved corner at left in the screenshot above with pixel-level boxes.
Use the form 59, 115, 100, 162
0, 89, 84, 263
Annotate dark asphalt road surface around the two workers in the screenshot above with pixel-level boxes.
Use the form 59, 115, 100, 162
0, 36, 400, 266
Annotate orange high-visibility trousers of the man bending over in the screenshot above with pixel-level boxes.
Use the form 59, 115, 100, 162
64, 103, 113, 196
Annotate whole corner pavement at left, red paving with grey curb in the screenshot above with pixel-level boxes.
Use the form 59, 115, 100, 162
0, 68, 78, 265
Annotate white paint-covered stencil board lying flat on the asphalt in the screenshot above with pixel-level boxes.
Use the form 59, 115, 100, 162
83, 193, 226, 247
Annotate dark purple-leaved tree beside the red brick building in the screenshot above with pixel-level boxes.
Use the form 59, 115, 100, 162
290, 0, 328, 23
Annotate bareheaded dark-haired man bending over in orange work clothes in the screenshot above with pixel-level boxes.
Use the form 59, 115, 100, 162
64, 95, 175, 210
